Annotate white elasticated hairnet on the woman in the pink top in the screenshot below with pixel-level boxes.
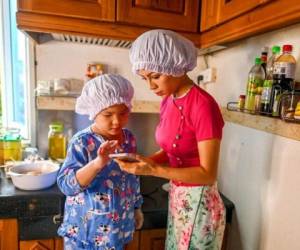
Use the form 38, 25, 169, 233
129, 29, 197, 76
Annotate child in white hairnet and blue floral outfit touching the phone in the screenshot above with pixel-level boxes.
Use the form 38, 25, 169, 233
57, 74, 143, 250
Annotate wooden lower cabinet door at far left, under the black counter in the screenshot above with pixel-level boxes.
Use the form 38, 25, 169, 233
0, 219, 18, 250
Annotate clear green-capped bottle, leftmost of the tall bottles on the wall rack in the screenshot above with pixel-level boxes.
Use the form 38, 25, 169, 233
245, 57, 265, 113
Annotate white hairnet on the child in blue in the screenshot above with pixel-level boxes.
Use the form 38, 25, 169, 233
75, 74, 134, 120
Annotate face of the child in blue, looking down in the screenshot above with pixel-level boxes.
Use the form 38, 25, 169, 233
94, 104, 129, 139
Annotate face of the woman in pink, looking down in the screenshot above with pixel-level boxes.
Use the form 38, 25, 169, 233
138, 70, 182, 96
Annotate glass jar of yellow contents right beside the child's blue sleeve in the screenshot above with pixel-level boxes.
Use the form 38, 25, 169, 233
48, 122, 67, 160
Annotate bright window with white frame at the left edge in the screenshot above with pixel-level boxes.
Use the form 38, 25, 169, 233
0, 0, 35, 145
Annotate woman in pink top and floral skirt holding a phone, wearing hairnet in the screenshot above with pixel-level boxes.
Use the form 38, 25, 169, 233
118, 30, 225, 250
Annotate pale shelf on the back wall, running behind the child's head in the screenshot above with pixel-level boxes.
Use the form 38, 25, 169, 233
36, 96, 160, 113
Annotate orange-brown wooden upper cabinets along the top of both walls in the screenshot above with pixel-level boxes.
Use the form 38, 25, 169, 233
17, 0, 300, 48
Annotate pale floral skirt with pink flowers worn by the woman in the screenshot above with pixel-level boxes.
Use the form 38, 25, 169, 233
165, 181, 225, 250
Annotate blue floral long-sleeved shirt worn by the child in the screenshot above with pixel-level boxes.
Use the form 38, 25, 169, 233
57, 127, 142, 249
